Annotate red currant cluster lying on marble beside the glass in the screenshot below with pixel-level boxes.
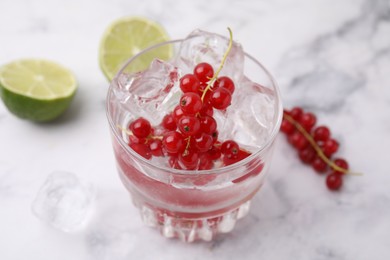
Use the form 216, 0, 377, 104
280, 107, 349, 190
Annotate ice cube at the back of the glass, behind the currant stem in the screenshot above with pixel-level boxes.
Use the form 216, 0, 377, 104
176, 30, 244, 82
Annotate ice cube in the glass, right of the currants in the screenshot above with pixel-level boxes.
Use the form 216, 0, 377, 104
215, 77, 276, 150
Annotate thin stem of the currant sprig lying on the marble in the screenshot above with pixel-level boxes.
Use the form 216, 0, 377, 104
283, 113, 362, 175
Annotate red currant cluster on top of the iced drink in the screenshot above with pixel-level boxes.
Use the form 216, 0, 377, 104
129, 63, 250, 170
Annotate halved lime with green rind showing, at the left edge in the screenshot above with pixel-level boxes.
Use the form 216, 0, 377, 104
0, 59, 77, 122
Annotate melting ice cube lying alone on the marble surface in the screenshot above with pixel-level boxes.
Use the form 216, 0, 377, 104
32, 172, 95, 232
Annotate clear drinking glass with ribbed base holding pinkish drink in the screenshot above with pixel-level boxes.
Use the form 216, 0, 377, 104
107, 32, 283, 242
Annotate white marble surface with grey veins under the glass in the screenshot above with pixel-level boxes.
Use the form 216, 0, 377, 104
0, 0, 390, 260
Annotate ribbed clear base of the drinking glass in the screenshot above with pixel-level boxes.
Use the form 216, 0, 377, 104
134, 201, 250, 242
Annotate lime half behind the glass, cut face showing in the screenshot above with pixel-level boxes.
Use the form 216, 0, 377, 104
99, 17, 172, 81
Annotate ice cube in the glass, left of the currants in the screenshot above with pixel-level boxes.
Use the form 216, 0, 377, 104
114, 59, 181, 125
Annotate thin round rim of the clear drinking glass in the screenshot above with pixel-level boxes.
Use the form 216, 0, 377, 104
106, 37, 283, 176
